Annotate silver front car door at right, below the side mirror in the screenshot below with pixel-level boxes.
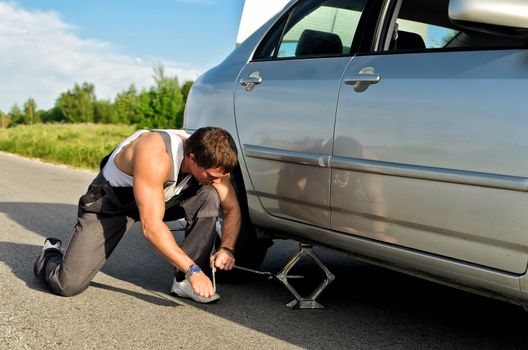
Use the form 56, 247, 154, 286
331, 0, 528, 274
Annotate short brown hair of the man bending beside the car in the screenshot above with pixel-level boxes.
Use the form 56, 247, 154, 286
184, 127, 238, 174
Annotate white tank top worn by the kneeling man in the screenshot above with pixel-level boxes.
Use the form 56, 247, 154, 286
103, 129, 192, 201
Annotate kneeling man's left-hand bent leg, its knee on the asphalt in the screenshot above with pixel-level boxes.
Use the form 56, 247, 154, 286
35, 213, 134, 296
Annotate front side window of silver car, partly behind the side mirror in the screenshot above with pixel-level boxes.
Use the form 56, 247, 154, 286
383, 0, 526, 52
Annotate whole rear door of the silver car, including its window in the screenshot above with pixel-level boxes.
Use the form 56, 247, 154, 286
234, 0, 366, 228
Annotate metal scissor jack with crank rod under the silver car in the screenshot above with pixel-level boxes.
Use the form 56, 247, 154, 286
230, 243, 335, 309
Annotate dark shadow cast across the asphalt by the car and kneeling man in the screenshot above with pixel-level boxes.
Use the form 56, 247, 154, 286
0, 203, 528, 349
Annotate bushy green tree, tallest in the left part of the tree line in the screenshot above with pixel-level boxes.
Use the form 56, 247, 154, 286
55, 82, 96, 123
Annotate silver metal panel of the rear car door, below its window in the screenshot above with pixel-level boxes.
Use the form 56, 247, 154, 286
235, 57, 350, 227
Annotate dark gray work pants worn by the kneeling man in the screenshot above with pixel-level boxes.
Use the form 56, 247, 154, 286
35, 173, 220, 296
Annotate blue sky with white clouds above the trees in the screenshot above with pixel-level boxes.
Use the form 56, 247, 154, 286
0, 0, 244, 112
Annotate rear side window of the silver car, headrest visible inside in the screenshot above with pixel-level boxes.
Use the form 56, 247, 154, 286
254, 0, 367, 59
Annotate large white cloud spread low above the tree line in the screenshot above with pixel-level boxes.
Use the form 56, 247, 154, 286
0, 2, 200, 112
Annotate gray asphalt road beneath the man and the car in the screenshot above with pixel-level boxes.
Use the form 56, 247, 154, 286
0, 153, 528, 350
